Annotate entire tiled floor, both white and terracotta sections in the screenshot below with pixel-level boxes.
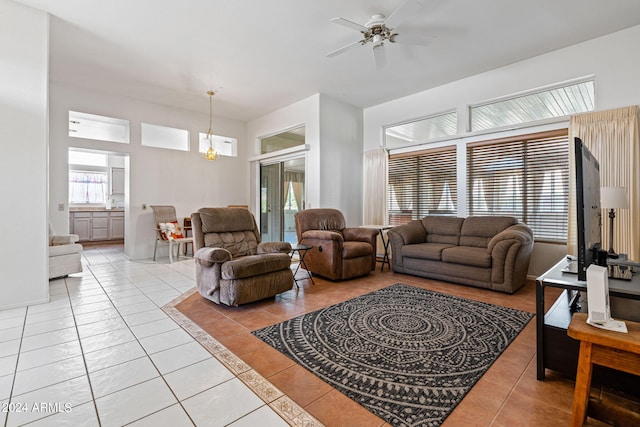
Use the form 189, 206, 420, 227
0, 247, 636, 426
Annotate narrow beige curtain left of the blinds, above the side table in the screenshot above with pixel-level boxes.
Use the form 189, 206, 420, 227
363, 148, 389, 225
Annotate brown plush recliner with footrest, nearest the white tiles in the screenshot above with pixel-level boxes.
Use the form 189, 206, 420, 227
191, 208, 293, 306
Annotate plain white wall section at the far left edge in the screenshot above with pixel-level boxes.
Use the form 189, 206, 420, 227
0, 0, 49, 310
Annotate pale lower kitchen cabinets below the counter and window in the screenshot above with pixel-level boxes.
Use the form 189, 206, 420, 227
69, 210, 124, 242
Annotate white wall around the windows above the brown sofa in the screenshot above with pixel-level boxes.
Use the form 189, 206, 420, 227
364, 26, 640, 276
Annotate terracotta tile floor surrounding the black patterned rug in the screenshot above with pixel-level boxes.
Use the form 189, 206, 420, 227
176, 269, 640, 427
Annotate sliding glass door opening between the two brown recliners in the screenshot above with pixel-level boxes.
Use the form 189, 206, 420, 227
260, 156, 305, 243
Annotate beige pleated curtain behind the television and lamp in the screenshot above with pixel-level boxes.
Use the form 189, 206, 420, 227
567, 106, 640, 261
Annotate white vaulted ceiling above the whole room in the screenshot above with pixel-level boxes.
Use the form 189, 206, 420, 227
13, 0, 640, 120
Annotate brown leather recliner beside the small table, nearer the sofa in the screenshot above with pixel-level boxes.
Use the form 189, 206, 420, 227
294, 209, 378, 280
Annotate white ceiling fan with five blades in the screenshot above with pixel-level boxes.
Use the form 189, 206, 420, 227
327, 0, 425, 68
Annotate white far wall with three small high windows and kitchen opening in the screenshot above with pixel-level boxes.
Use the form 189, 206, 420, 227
49, 82, 249, 259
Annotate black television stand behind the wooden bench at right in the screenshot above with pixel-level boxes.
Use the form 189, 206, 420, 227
536, 258, 640, 396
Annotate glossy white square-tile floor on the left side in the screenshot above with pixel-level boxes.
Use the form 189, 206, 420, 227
0, 246, 288, 427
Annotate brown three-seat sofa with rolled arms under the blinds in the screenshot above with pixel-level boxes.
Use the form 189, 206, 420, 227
388, 216, 533, 293
